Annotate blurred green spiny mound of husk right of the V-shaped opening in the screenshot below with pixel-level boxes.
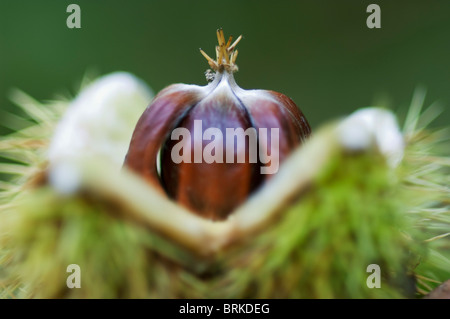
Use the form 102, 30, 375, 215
221, 150, 416, 298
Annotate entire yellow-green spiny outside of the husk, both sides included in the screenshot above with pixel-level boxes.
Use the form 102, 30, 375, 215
0, 86, 450, 298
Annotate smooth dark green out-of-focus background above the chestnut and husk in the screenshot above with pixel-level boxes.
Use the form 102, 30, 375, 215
0, 0, 450, 134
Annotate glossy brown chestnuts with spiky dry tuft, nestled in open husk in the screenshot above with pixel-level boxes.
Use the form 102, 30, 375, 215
125, 29, 311, 220
